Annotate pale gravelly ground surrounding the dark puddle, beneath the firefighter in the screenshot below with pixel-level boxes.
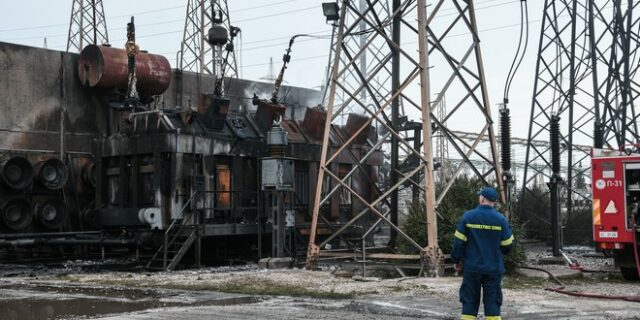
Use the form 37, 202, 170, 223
4, 266, 640, 320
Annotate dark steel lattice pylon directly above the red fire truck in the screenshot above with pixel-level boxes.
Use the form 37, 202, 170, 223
589, 0, 640, 149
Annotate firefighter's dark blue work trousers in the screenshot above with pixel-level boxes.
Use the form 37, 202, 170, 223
460, 270, 502, 319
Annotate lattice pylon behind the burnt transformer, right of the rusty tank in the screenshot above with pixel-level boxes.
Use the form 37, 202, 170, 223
179, 0, 239, 78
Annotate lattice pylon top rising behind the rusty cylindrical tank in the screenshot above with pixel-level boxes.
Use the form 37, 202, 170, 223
67, 0, 109, 52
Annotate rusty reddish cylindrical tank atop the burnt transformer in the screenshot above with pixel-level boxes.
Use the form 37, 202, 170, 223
78, 44, 171, 96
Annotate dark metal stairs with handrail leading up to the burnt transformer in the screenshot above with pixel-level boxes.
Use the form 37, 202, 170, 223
146, 192, 201, 271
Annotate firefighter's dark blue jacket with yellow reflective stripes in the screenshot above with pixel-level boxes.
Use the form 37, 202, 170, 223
451, 205, 513, 273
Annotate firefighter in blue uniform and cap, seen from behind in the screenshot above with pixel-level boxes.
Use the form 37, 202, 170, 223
451, 188, 513, 320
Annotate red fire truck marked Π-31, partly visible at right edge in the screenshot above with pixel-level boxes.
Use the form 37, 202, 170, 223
591, 149, 640, 280
